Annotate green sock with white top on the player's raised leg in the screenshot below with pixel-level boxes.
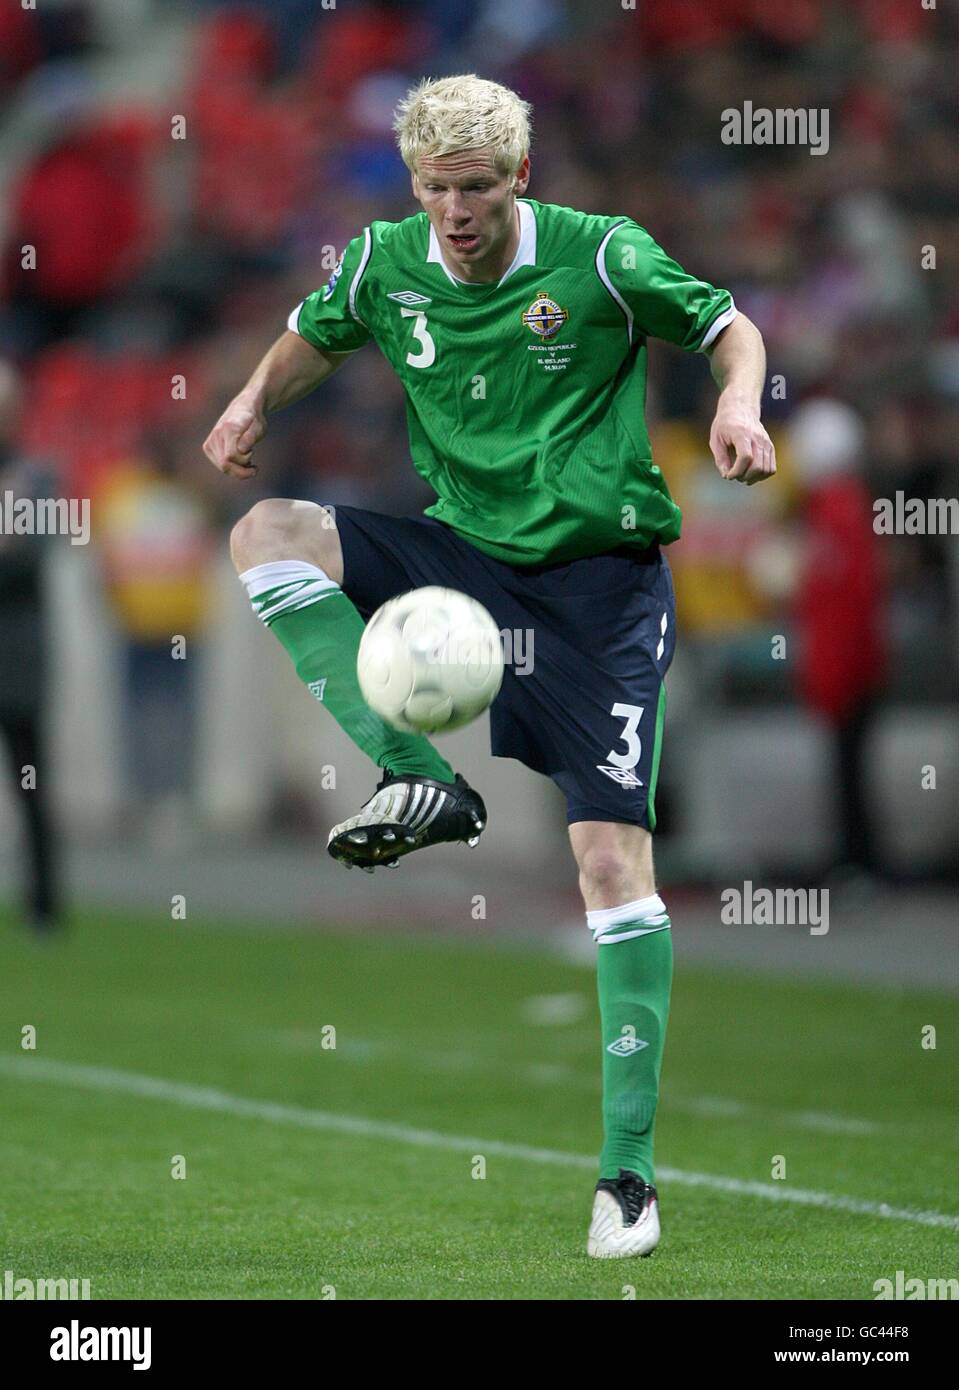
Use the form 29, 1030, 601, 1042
240, 560, 456, 781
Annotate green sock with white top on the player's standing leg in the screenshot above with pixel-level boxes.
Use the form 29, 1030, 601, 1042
588, 897, 673, 1183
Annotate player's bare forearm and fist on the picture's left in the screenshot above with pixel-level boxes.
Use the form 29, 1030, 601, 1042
203, 329, 352, 478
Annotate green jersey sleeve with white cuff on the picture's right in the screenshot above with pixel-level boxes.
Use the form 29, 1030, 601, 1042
598, 221, 737, 352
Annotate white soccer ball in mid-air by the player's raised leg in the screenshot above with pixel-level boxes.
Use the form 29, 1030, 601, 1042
356, 585, 503, 734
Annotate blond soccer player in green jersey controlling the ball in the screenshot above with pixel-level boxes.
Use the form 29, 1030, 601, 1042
204, 75, 776, 1258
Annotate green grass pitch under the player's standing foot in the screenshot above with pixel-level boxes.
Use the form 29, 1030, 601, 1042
0, 913, 959, 1300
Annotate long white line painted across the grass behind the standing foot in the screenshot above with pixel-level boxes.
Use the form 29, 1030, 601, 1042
0, 1055, 959, 1230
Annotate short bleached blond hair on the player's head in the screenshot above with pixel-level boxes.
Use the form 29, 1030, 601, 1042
393, 72, 532, 174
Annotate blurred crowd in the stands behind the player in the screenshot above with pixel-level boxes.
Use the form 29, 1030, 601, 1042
0, 0, 959, 878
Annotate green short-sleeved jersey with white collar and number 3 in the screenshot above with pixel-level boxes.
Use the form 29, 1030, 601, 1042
289, 199, 737, 566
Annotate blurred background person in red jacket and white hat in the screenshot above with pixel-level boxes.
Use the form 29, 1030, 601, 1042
789, 398, 885, 874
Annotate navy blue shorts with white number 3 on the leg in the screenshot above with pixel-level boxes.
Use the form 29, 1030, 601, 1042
334, 506, 675, 830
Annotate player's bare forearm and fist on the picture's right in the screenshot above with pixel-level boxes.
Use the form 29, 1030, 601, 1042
709, 313, 776, 487
